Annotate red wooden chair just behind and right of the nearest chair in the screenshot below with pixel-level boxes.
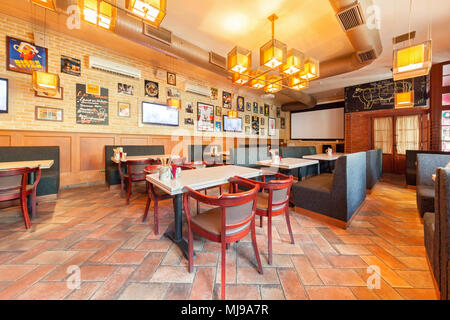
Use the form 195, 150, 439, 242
238, 173, 294, 264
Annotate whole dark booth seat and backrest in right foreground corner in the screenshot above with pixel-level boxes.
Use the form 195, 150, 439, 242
423, 168, 450, 300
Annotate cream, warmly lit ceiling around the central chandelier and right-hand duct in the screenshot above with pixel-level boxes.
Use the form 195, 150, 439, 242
162, 0, 450, 101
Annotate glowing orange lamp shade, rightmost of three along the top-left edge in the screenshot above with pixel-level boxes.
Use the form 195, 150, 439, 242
127, 0, 167, 27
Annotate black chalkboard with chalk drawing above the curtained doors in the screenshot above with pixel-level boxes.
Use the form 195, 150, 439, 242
345, 76, 427, 113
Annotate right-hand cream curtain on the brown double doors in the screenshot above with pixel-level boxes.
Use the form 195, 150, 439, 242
395, 115, 420, 154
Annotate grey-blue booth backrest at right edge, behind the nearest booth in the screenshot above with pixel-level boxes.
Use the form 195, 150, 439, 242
416, 153, 450, 186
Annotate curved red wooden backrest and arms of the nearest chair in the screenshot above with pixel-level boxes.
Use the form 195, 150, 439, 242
184, 177, 259, 234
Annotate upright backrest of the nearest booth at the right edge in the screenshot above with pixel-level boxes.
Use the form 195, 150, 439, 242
433, 168, 450, 300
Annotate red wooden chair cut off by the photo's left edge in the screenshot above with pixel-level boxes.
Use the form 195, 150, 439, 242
0, 167, 41, 229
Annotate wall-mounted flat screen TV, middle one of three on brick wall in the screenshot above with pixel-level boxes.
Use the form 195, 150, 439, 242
142, 102, 179, 126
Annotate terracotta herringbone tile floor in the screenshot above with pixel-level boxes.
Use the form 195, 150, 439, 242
0, 176, 437, 299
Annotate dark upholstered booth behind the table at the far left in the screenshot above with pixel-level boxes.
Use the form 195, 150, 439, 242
0, 146, 60, 197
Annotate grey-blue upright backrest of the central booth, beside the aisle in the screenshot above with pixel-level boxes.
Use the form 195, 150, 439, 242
332, 152, 367, 221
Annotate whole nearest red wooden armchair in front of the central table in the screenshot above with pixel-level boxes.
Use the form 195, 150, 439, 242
183, 178, 263, 299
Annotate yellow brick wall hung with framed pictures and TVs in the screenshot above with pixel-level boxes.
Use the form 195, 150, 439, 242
0, 15, 289, 139
